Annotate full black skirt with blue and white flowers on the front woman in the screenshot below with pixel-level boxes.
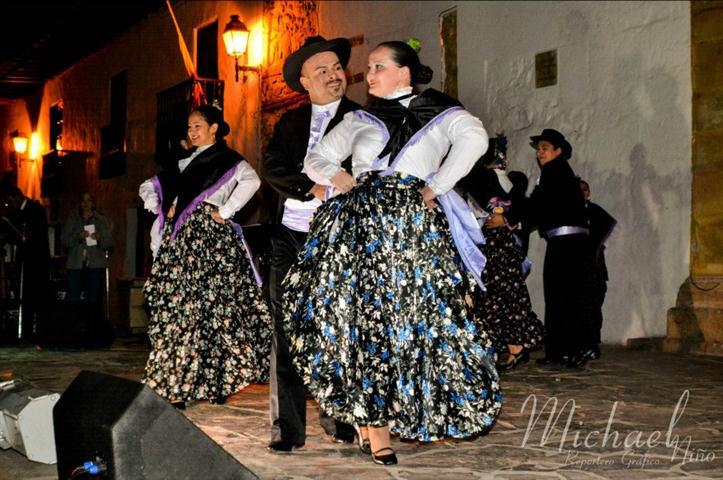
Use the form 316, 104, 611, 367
284, 174, 502, 441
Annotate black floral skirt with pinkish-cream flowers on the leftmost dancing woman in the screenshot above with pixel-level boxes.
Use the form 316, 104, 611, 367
143, 203, 271, 401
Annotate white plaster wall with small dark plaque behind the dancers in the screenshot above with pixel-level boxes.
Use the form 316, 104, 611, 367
319, 1, 692, 343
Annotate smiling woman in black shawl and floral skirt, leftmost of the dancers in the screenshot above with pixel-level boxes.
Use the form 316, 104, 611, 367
140, 105, 271, 408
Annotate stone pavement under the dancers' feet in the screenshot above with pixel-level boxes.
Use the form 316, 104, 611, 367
0, 345, 723, 480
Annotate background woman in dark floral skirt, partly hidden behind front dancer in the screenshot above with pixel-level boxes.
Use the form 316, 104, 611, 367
457, 134, 544, 370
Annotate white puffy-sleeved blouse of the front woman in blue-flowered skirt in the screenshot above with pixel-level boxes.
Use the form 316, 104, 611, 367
304, 103, 489, 195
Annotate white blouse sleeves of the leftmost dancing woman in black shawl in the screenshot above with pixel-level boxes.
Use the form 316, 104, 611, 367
138, 160, 261, 219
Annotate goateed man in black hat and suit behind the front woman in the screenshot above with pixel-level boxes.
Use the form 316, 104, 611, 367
261, 36, 360, 452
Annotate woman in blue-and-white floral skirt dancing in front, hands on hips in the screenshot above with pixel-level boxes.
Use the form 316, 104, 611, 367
284, 42, 502, 465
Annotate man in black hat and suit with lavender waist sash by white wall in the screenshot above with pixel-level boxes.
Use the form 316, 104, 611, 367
529, 128, 597, 367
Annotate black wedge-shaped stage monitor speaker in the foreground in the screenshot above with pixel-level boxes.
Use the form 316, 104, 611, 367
53, 371, 258, 480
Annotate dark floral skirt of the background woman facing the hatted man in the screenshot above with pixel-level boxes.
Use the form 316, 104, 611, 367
474, 227, 545, 352
